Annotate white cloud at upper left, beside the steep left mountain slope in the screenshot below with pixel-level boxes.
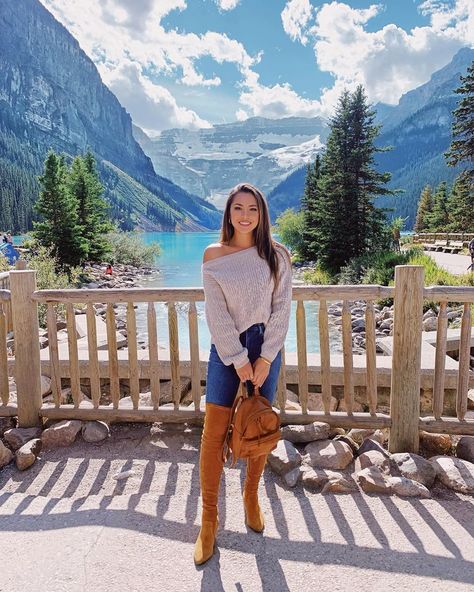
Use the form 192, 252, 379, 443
41, 0, 260, 133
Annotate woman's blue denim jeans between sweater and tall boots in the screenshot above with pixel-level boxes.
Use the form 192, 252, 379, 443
206, 323, 281, 407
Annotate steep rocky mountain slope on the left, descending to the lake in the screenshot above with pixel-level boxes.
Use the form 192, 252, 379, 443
0, 0, 221, 231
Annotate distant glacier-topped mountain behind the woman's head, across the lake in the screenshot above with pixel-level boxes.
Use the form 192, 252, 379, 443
133, 117, 327, 207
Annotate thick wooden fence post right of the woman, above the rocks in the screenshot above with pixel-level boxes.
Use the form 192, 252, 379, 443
389, 265, 424, 453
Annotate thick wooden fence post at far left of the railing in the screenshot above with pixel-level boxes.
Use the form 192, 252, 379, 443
10, 271, 42, 427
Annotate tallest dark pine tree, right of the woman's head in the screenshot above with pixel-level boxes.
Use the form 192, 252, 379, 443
317, 86, 395, 272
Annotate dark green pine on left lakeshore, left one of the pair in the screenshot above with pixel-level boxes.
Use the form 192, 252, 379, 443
34, 152, 87, 267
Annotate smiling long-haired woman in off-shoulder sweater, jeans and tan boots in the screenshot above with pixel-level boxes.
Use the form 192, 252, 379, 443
194, 183, 291, 564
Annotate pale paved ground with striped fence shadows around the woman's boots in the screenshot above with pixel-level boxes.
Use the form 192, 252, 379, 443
0, 425, 474, 592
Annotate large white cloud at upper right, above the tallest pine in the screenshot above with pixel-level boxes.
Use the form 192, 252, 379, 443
282, 0, 474, 115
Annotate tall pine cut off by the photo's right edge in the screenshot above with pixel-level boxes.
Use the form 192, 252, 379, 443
445, 62, 474, 182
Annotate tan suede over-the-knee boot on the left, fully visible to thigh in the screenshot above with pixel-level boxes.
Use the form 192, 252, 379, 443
194, 403, 231, 565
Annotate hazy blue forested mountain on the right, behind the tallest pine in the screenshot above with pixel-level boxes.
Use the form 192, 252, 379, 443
268, 48, 474, 228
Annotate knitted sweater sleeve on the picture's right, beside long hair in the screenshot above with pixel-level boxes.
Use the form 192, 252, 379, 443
261, 248, 292, 362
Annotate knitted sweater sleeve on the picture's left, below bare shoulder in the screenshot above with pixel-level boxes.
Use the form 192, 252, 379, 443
202, 270, 249, 368
